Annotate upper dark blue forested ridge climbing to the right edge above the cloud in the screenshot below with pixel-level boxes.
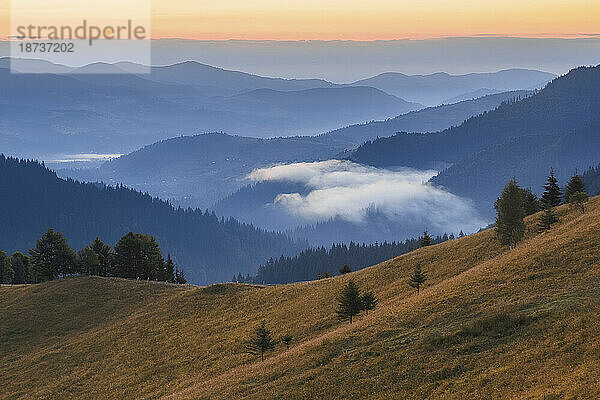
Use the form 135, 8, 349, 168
349, 66, 600, 168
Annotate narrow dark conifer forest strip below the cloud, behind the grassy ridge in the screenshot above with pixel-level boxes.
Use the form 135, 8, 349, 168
253, 235, 448, 283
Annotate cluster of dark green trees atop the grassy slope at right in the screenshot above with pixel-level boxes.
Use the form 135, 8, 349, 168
495, 170, 589, 249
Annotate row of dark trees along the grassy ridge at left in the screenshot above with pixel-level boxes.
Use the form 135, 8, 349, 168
0, 229, 186, 284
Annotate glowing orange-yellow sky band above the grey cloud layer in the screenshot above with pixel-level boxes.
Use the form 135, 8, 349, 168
0, 0, 600, 40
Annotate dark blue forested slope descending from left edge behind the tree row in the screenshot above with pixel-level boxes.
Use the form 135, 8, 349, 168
0, 155, 305, 283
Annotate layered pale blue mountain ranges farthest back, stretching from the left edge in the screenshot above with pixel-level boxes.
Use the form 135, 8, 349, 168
0, 58, 548, 157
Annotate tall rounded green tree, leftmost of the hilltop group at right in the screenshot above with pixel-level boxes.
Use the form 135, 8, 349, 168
496, 179, 525, 249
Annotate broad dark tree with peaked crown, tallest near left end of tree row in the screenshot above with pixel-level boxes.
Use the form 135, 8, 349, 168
29, 229, 76, 282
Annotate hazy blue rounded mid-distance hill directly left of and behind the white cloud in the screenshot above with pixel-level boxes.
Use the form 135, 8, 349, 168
60, 133, 344, 207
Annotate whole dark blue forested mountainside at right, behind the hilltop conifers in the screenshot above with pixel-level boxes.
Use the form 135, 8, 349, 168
349, 66, 600, 215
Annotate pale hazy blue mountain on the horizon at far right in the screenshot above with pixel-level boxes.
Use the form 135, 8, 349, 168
353, 69, 555, 106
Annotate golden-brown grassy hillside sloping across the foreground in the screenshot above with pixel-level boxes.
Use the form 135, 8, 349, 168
0, 198, 600, 399
